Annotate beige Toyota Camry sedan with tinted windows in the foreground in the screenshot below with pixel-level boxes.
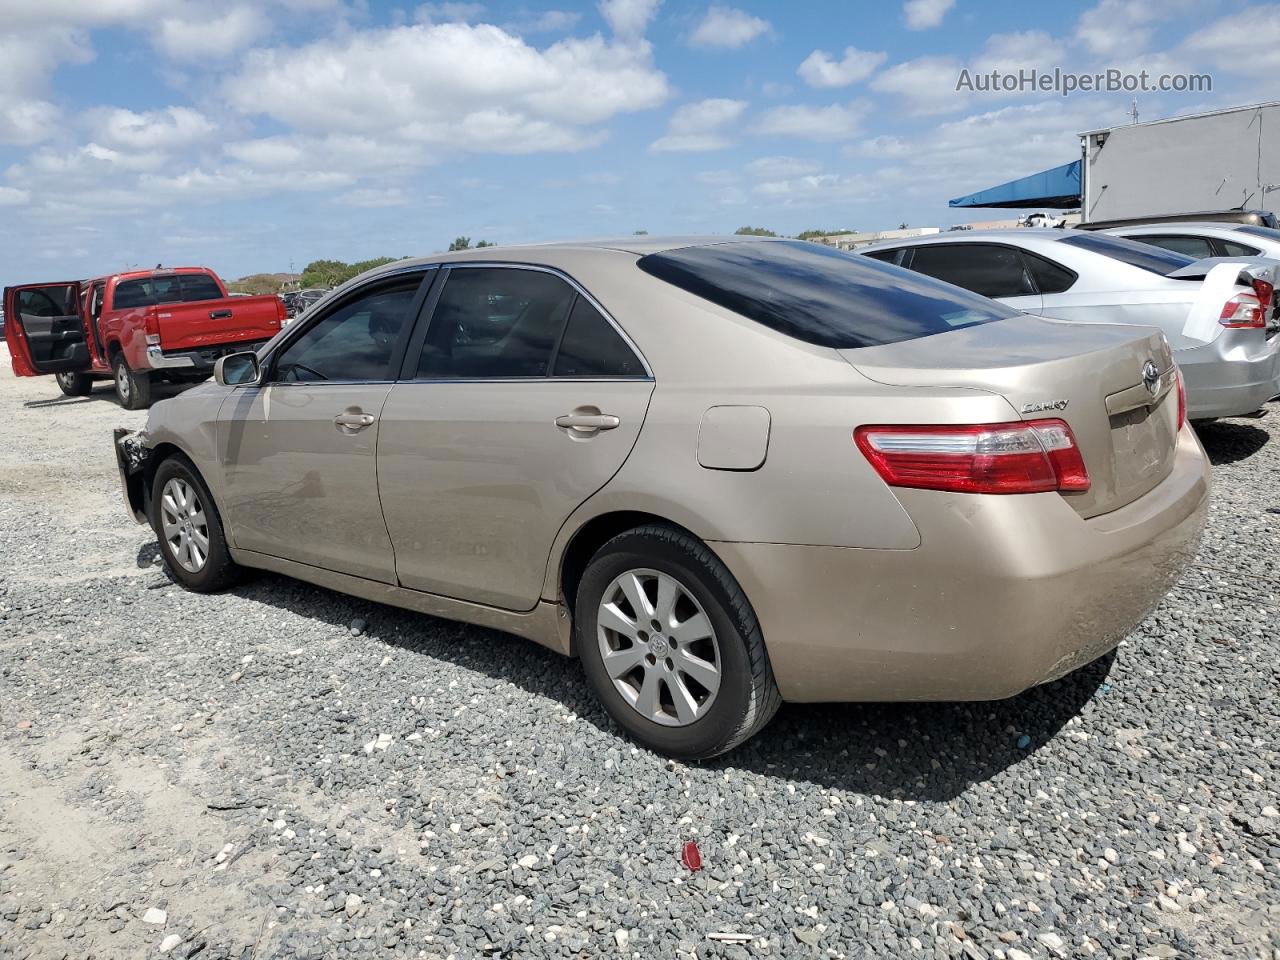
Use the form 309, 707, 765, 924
116, 237, 1208, 756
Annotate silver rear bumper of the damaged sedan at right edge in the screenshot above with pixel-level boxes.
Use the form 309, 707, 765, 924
1174, 330, 1280, 420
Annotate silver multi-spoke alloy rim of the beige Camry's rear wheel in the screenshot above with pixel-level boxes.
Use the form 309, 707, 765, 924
596, 570, 722, 727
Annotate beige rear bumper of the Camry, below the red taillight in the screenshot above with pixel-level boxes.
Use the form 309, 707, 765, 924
712, 428, 1210, 701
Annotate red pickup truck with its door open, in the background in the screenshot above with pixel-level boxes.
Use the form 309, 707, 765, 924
4, 266, 285, 410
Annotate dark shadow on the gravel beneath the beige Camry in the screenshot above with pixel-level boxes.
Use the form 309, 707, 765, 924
192, 563, 1115, 800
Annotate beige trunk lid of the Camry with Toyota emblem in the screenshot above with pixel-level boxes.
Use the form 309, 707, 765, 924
840, 315, 1178, 517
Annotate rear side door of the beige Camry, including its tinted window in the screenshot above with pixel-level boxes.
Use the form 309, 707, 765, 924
378, 265, 653, 611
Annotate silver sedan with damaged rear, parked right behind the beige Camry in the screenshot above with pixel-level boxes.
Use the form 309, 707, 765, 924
858, 230, 1280, 420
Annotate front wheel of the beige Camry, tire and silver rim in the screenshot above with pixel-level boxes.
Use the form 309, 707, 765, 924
151, 454, 241, 593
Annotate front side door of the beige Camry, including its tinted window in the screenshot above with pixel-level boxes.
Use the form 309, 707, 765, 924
219, 270, 435, 584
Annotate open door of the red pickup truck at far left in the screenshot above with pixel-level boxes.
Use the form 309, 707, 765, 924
4, 280, 92, 376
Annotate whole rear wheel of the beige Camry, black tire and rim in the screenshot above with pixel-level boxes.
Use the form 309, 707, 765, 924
575, 525, 782, 759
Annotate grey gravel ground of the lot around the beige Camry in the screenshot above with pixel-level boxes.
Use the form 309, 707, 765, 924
0, 357, 1280, 960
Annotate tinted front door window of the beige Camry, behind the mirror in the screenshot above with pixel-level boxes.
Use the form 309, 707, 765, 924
274, 276, 421, 380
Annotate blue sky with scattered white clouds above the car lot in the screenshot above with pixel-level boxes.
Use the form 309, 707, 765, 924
0, 0, 1280, 284
